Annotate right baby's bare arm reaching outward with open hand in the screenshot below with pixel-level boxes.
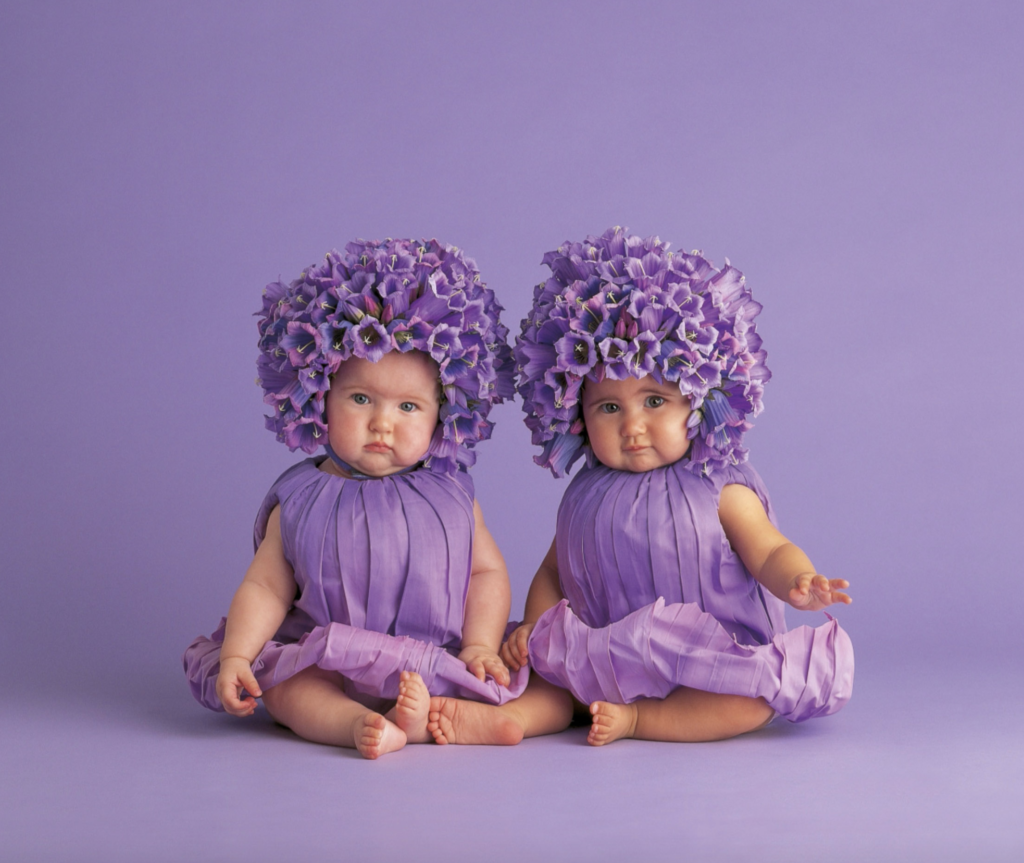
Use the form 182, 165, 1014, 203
718, 484, 853, 611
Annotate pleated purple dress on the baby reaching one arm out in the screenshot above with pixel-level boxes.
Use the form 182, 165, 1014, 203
529, 462, 853, 722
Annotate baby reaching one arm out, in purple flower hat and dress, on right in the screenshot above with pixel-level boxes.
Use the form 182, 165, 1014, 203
430, 228, 853, 745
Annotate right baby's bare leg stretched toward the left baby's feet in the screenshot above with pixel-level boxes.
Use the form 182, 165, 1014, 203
427, 675, 572, 745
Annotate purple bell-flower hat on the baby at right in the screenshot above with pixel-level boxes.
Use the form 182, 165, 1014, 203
514, 227, 771, 476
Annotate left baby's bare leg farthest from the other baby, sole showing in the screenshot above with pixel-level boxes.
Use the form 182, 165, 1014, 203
263, 665, 406, 759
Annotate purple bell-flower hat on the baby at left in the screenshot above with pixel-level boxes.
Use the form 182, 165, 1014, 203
256, 240, 515, 473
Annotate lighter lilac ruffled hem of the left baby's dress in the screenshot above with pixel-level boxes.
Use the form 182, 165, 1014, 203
182, 618, 529, 710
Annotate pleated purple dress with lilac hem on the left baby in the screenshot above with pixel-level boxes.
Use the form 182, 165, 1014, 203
183, 459, 527, 710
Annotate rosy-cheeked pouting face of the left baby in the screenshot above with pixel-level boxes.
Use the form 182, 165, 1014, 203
327, 351, 440, 476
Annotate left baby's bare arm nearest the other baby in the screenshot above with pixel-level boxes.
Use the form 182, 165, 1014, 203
459, 501, 512, 686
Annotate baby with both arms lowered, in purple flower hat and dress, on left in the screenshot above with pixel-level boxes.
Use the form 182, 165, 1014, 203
184, 241, 526, 759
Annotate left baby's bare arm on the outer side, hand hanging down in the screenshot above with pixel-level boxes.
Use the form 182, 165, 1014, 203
217, 507, 295, 717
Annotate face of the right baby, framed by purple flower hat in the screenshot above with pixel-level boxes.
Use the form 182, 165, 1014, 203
583, 375, 690, 473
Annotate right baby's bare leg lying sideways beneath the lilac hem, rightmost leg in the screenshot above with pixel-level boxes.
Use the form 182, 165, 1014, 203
587, 686, 774, 746
